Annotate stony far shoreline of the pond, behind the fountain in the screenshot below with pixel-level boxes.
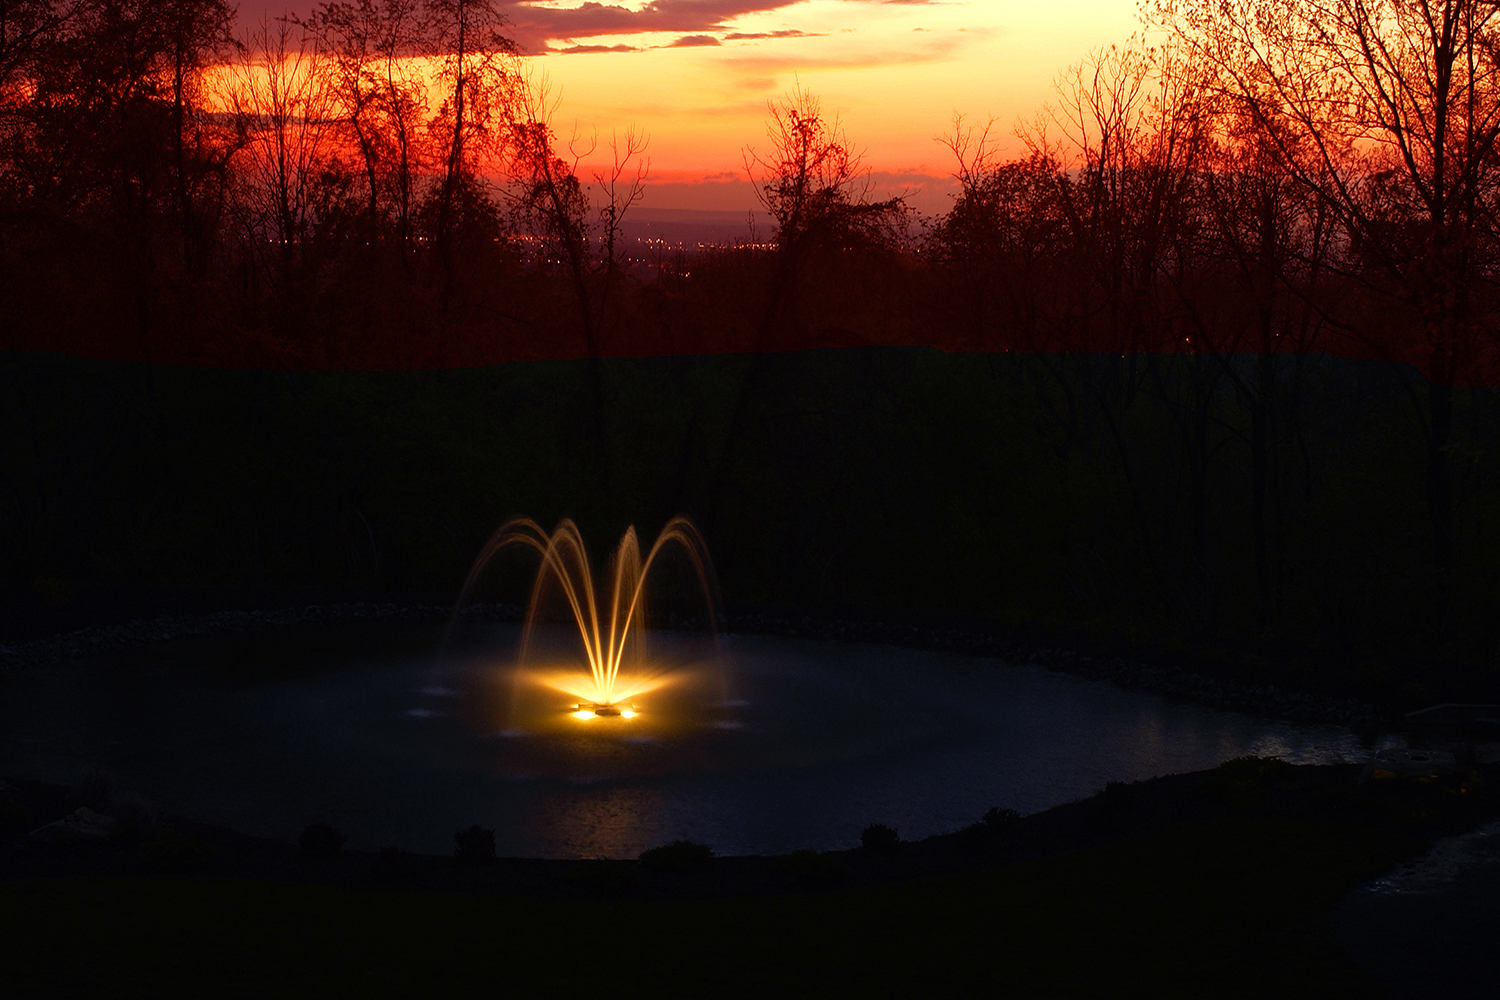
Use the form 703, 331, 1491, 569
0, 601, 1380, 730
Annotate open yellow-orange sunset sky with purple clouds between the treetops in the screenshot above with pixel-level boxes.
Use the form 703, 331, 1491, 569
240, 0, 1139, 211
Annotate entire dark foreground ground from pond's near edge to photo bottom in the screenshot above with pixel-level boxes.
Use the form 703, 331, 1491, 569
0, 760, 1500, 997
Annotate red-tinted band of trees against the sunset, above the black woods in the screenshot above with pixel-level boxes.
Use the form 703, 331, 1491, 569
0, 0, 1500, 374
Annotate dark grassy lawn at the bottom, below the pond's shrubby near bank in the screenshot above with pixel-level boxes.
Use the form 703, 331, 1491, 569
0, 820, 1413, 997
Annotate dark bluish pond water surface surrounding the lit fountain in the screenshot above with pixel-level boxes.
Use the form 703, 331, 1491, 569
0, 624, 1404, 858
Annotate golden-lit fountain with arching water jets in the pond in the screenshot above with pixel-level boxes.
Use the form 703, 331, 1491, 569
450, 517, 714, 720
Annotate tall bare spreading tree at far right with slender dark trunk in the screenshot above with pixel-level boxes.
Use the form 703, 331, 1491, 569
1154, 0, 1500, 631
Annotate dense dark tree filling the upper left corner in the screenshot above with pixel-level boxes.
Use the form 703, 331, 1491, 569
3, 0, 234, 354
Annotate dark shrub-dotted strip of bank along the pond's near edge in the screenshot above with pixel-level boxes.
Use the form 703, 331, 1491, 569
0, 757, 1500, 900
